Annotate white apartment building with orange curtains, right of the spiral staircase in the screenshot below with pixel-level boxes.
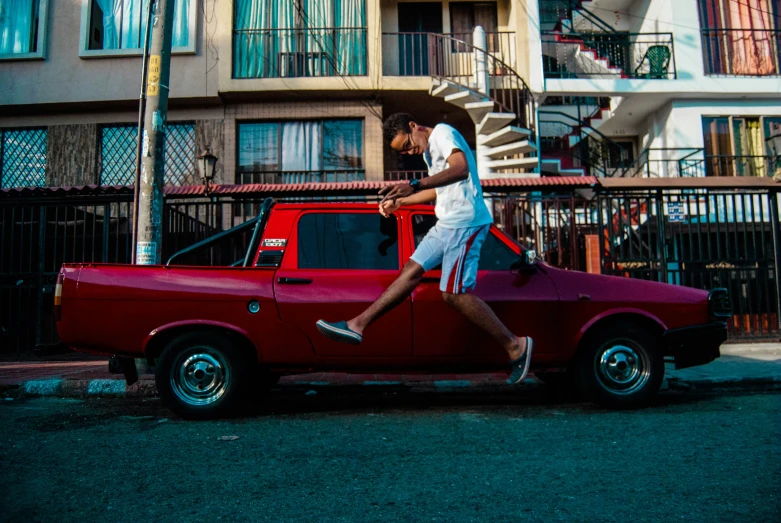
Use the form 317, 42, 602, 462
529, 0, 781, 177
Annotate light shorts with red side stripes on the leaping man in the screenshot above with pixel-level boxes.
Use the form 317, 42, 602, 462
410, 224, 491, 294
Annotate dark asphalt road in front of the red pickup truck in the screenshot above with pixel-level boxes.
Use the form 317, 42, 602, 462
0, 390, 781, 523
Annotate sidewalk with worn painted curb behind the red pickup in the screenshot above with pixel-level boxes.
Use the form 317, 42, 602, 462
0, 343, 781, 397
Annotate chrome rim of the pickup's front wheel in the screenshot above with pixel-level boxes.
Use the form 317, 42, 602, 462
594, 343, 651, 396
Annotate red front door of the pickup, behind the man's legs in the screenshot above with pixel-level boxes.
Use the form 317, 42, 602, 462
411, 214, 560, 361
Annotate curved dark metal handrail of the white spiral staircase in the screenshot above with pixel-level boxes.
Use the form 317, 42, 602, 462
420, 33, 536, 138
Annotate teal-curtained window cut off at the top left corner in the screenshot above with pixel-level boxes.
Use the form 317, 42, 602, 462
0, 0, 45, 55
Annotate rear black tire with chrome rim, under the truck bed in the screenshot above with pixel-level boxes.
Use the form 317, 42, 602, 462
155, 332, 250, 419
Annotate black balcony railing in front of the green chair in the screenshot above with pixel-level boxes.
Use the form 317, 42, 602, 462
541, 31, 677, 80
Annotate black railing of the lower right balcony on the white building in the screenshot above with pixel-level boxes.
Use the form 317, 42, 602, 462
625, 148, 781, 178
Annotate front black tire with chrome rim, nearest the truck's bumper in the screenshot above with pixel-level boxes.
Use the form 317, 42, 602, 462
575, 323, 664, 408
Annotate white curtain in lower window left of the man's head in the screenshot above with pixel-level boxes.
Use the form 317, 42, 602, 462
282, 122, 322, 183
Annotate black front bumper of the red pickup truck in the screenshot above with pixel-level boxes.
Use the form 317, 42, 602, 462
662, 322, 727, 369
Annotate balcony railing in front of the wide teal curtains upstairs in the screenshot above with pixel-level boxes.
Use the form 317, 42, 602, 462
233, 27, 366, 78
